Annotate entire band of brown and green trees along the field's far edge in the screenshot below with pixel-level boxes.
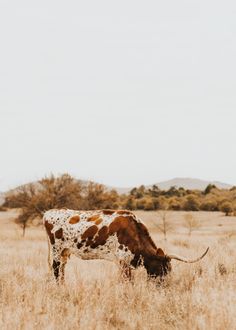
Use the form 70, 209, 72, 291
3, 174, 236, 233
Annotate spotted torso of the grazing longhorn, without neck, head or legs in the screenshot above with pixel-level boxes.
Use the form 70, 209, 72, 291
43, 209, 142, 262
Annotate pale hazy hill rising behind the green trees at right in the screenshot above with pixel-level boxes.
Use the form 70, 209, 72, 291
151, 178, 232, 190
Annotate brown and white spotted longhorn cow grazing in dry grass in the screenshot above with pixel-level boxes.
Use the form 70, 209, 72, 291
43, 209, 208, 279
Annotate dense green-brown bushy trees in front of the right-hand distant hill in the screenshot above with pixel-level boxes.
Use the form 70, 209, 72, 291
122, 184, 236, 216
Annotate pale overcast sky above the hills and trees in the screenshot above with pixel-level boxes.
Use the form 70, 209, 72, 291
0, 0, 236, 191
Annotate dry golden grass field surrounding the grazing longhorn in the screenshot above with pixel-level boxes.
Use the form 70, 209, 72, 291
0, 211, 236, 330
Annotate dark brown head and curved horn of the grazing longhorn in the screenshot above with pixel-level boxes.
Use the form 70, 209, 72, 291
144, 248, 209, 277
